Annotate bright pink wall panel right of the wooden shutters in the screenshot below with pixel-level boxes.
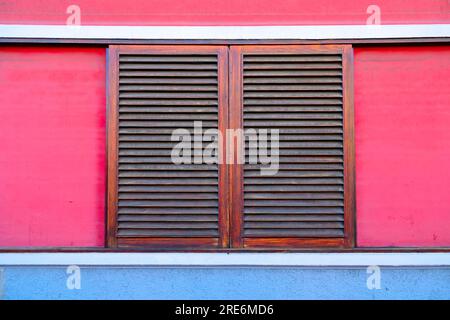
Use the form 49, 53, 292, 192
355, 46, 450, 246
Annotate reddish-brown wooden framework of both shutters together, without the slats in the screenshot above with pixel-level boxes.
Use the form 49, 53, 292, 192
106, 44, 355, 251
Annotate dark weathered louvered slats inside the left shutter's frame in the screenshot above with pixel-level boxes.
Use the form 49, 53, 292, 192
117, 51, 219, 241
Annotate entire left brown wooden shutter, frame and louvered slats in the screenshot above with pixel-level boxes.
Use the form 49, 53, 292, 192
108, 46, 228, 248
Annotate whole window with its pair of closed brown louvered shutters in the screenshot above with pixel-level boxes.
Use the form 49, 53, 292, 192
108, 45, 354, 249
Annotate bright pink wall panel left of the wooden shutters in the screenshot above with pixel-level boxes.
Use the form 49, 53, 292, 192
0, 47, 105, 246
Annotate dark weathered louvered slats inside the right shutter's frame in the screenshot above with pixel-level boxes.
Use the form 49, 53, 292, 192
242, 50, 344, 238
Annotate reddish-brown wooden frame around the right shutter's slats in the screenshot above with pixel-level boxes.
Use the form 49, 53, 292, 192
230, 45, 355, 249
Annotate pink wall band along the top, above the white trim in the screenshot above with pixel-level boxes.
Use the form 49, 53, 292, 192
0, 0, 450, 25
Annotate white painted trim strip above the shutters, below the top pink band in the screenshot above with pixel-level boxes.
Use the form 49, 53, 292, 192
0, 24, 450, 40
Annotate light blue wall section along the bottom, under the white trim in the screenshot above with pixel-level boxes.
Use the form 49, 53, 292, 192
0, 266, 450, 299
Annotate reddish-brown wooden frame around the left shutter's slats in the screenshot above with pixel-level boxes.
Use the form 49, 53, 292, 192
106, 45, 229, 250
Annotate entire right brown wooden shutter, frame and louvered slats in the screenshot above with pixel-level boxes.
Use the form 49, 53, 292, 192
230, 46, 354, 247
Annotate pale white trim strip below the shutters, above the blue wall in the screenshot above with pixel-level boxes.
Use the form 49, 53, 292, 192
0, 252, 450, 267
